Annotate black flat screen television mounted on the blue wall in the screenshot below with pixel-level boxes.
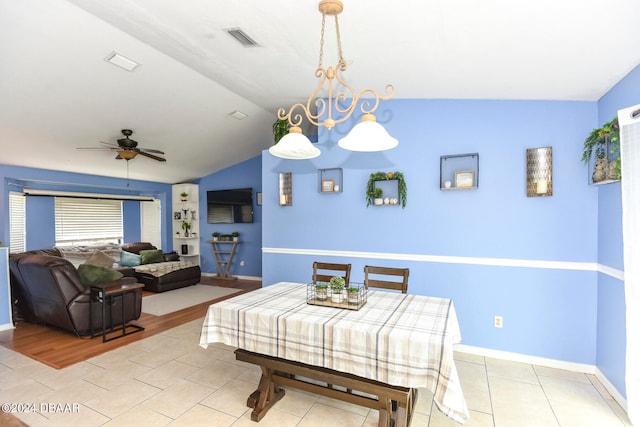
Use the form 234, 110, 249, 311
207, 188, 253, 224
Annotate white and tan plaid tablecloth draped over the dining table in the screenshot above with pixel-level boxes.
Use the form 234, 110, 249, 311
200, 282, 469, 423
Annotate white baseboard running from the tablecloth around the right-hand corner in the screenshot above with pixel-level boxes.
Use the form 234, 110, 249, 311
453, 344, 627, 411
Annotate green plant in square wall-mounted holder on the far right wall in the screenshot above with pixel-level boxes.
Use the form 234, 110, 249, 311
582, 117, 622, 183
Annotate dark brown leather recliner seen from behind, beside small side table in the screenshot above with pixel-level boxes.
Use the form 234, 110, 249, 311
9, 254, 142, 336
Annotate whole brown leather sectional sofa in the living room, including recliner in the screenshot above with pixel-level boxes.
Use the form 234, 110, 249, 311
9, 242, 201, 335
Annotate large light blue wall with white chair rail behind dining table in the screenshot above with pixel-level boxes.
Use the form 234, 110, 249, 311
263, 100, 597, 364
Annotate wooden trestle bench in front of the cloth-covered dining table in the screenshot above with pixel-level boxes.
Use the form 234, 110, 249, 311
235, 349, 417, 427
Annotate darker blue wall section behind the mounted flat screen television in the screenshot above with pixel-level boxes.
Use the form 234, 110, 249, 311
198, 156, 262, 277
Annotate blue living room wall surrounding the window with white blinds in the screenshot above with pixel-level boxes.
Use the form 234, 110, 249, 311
0, 165, 173, 251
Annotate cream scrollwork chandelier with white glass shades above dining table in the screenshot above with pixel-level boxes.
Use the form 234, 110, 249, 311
269, 0, 398, 159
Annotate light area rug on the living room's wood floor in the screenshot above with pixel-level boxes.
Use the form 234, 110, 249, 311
142, 285, 242, 316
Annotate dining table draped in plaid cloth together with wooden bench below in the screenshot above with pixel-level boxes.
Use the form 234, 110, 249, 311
200, 282, 469, 426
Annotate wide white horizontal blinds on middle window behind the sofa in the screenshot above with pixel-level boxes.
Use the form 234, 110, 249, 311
55, 197, 123, 246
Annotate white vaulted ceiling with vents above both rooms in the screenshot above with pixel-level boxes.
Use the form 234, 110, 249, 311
0, 0, 640, 183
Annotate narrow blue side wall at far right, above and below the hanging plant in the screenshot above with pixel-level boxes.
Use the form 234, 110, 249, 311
594, 62, 640, 396
